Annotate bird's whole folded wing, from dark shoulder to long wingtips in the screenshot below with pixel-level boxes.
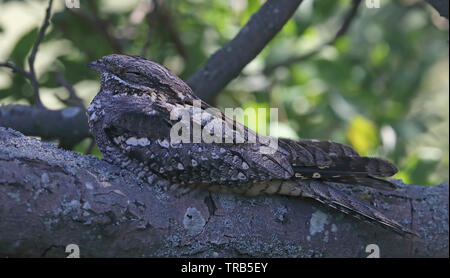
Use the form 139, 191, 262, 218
105, 97, 396, 190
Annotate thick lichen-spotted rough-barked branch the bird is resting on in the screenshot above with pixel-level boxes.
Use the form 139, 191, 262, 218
0, 127, 449, 257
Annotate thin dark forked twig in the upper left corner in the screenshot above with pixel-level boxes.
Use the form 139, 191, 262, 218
0, 0, 53, 107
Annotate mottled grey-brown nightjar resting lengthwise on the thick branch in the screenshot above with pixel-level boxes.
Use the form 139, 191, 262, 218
88, 54, 416, 235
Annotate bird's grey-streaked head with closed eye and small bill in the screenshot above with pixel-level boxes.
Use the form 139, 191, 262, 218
88, 54, 192, 100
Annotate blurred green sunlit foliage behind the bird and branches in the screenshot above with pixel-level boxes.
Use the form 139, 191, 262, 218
0, 0, 449, 185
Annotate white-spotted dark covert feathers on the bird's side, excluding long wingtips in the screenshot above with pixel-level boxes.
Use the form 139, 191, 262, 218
104, 100, 292, 186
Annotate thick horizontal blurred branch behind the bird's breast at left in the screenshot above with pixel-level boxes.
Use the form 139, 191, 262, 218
0, 105, 91, 149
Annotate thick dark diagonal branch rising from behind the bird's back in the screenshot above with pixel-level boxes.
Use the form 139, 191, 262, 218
187, 0, 302, 101
